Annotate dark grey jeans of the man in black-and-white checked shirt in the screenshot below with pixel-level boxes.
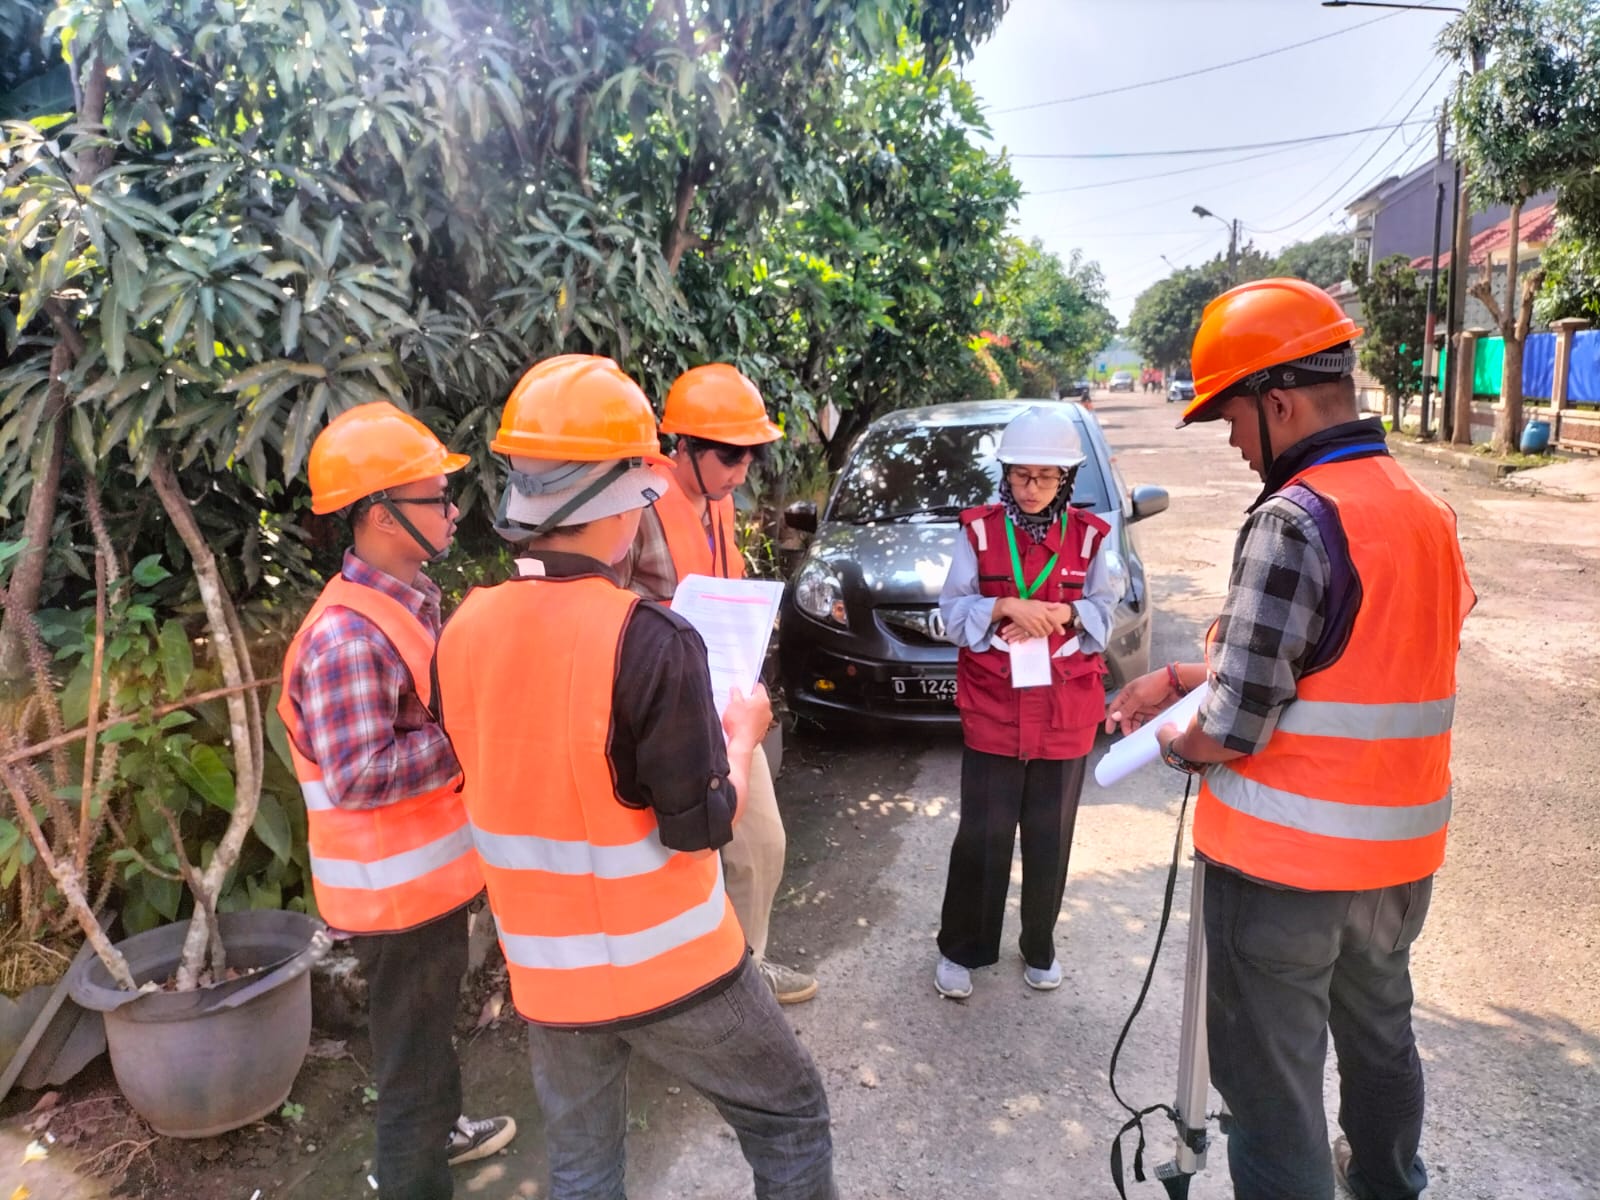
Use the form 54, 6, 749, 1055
1205, 866, 1434, 1200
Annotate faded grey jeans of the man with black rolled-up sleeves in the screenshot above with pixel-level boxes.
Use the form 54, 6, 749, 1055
528, 958, 838, 1200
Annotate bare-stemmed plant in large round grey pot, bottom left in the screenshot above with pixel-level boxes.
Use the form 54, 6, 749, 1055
0, 480, 328, 1138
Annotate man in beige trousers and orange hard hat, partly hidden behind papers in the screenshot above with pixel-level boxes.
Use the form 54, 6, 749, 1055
622, 363, 816, 1005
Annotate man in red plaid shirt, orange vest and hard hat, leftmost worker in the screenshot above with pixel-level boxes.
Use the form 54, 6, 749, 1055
278, 402, 517, 1200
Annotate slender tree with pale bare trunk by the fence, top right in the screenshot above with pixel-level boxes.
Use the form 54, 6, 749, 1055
1440, 0, 1600, 453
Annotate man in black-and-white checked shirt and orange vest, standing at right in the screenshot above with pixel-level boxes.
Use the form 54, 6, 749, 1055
1106, 278, 1474, 1200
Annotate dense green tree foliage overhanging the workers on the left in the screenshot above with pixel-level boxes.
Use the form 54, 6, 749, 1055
0, 0, 1107, 966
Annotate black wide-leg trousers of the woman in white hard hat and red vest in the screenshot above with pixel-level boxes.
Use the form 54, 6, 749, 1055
939, 746, 1088, 970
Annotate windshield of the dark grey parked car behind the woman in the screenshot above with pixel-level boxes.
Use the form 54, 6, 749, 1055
827, 424, 1112, 525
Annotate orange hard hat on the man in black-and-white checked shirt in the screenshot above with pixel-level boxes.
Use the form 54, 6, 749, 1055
1179, 278, 1362, 426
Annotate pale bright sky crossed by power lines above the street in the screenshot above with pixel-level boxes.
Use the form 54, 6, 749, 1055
963, 0, 1456, 322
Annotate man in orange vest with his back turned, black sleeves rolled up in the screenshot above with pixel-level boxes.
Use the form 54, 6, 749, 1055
434, 354, 837, 1200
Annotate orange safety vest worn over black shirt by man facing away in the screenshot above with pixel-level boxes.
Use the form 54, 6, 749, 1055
434, 576, 746, 1026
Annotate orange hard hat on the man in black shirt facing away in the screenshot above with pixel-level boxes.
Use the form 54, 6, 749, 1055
490, 354, 666, 462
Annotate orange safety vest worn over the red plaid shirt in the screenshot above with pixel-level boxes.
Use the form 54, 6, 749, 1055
278, 576, 483, 933
